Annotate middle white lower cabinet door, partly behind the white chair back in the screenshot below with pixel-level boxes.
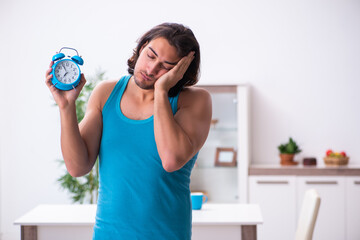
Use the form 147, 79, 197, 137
297, 176, 345, 240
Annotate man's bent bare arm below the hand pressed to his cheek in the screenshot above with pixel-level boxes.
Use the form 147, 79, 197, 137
154, 89, 212, 172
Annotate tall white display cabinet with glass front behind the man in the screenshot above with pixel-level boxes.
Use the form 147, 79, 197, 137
190, 85, 250, 203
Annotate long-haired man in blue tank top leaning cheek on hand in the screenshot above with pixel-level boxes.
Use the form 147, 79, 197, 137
46, 23, 211, 240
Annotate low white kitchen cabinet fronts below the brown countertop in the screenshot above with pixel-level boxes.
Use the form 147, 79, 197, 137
249, 174, 360, 240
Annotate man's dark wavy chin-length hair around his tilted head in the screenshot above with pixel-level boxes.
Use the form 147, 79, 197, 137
127, 23, 200, 97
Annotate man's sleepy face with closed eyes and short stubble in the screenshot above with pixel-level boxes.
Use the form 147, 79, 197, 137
134, 37, 180, 89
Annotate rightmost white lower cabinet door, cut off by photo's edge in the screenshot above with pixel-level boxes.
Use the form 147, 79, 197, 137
346, 177, 360, 240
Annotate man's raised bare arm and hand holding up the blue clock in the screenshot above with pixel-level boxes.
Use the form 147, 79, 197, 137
46, 63, 102, 177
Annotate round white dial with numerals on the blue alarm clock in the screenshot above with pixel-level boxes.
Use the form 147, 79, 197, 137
54, 59, 80, 84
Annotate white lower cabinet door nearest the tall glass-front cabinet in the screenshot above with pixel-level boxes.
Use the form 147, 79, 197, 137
249, 176, 296, 240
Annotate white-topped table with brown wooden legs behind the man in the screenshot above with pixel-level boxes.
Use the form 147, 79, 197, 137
14, 203, 263, 240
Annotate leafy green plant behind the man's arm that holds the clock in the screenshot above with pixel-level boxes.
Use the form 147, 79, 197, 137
57, 69, 105, 204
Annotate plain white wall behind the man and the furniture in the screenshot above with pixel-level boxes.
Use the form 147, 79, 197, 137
0, 0, 360, 240
